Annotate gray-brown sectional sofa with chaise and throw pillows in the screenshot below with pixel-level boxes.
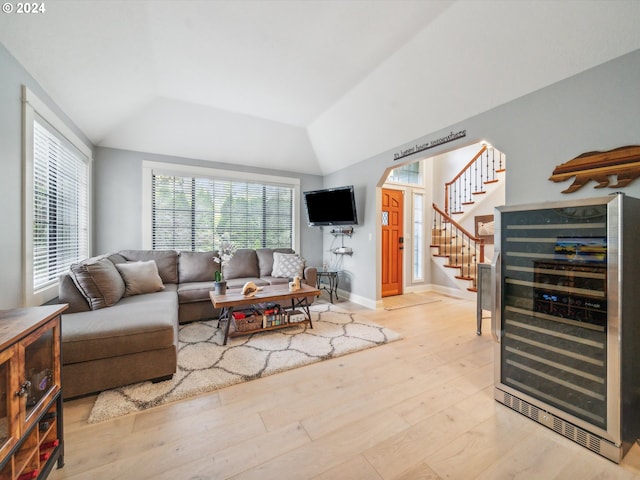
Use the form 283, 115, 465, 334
56, 248, 317, 398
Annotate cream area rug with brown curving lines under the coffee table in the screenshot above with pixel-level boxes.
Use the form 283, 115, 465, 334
88, 304, 401, 423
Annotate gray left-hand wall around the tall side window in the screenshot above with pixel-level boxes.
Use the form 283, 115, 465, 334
0, 43, 91, 309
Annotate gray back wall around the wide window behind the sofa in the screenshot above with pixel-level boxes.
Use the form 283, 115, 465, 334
94, 147, 322, 266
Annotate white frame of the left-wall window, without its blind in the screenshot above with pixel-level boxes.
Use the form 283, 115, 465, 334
22, 85, 93, 307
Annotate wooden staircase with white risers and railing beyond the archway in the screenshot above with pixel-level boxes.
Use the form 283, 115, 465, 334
430, 145, 505, 296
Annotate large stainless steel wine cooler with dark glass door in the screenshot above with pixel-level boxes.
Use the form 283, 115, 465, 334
491, 194, 640, 462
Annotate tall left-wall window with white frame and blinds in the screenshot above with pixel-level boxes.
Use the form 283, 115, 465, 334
23, 88, 91, 305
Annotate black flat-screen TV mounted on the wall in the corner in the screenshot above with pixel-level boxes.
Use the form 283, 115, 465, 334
304, 185, 358, 227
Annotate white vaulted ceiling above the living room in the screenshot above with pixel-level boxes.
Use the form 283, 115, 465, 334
0, 0, 640, 174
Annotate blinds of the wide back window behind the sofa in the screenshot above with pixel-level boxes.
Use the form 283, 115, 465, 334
151, 173, 294, 251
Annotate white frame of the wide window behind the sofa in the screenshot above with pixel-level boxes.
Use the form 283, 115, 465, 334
142, 160, 301, 252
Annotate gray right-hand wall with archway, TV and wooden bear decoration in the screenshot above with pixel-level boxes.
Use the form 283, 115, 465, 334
323, 50, 640, 305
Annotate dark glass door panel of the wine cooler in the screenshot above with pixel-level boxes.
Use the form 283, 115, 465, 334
497, 197, 617, 434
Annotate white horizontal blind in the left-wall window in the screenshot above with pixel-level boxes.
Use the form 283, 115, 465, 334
32, 116, 89, 291
